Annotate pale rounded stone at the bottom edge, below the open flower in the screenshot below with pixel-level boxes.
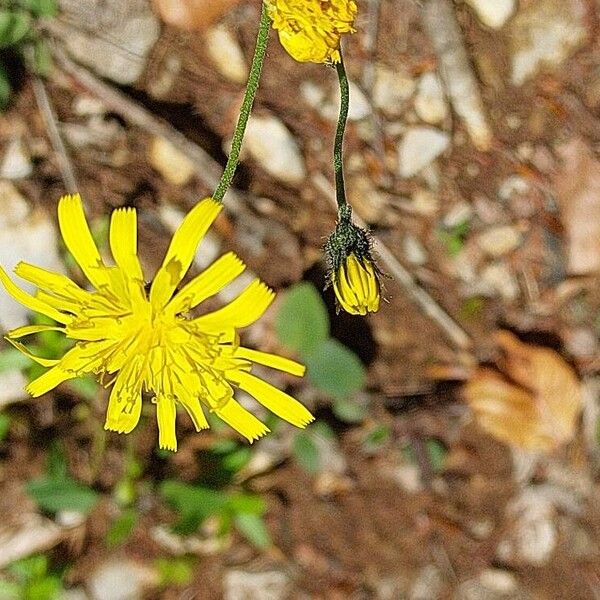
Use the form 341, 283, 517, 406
88, 559, 158, 600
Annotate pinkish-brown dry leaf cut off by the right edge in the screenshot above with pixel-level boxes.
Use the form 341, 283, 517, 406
554, 138, 600, 275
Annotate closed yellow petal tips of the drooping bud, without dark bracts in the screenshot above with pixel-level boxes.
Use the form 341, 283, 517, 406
332, 254, 380, 315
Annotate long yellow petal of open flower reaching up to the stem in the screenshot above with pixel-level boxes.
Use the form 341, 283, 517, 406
150, 198, 223, 309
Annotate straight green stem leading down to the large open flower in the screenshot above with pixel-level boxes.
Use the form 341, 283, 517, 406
213, 2, 271, 202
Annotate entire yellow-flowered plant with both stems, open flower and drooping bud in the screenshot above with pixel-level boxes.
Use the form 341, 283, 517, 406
0, 0, 380, 450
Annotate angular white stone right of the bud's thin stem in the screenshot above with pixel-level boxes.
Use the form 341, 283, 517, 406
398, 127, 450, 178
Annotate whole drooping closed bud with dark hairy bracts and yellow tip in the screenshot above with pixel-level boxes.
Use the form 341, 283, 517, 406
325, 204, 381, 315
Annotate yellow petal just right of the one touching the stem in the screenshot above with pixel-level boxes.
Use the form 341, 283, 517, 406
165, 252, 246, 315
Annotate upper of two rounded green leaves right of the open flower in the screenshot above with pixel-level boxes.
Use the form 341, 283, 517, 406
275, 283, 329, 355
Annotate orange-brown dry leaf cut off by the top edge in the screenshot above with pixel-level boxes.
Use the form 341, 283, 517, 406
153, 0, 241, 31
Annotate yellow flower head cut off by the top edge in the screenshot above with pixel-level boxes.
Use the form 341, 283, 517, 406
265, 0, 357, 63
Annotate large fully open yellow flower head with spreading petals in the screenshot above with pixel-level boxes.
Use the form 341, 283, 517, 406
0, 195, 313, 450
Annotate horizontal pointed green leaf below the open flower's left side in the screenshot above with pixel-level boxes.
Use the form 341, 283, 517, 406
26, 477, 99, 514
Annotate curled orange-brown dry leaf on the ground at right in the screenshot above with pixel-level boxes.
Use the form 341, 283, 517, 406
463, 331, 581, 452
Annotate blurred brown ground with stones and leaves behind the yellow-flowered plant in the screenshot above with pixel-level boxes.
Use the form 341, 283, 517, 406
0, 0, 600, 600
